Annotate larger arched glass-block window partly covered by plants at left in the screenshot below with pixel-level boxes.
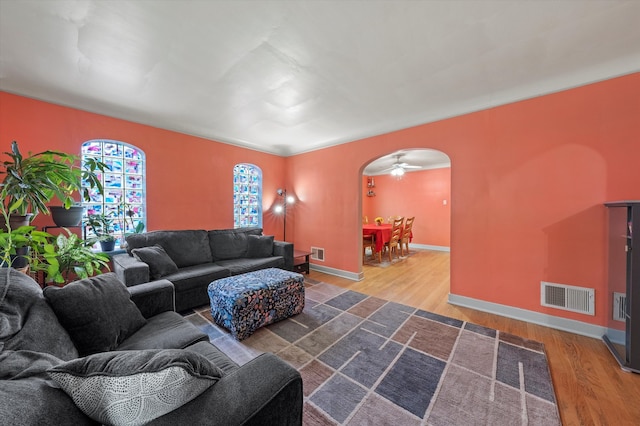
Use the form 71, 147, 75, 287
82, 139, 147, 243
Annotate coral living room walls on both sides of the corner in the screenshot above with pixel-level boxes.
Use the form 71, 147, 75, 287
0, 73, 640, 325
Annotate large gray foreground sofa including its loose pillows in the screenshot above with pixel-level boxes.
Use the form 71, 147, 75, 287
0, 268, 303, 426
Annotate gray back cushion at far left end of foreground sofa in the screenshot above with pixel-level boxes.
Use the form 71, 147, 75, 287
0, 268, 78, 361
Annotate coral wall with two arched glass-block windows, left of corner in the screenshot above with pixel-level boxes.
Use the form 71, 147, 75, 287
0, 92, 285, 238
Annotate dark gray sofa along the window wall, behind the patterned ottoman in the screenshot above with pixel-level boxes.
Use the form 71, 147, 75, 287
112, 228, 293, 312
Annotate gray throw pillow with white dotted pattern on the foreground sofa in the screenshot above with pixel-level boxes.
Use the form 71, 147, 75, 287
47, 349, 222, 425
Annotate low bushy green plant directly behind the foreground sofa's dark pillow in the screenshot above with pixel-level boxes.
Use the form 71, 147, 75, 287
47, 228, 110, 284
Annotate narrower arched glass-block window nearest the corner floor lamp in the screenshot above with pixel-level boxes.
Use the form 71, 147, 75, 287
233, 164, 262, 228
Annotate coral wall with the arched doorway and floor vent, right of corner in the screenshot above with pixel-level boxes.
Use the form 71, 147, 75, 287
287, 73, 640, 325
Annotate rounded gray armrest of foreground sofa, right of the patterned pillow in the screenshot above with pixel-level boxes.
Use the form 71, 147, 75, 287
150, 353, 302, 425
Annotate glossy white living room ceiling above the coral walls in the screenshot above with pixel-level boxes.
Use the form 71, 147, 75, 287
0, 0, 640, 156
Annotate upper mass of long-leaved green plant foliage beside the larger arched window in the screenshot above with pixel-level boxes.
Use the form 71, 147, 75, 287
0, 141, 107, 227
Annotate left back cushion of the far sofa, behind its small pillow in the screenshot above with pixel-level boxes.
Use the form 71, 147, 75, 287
127, 230, 213, 268
